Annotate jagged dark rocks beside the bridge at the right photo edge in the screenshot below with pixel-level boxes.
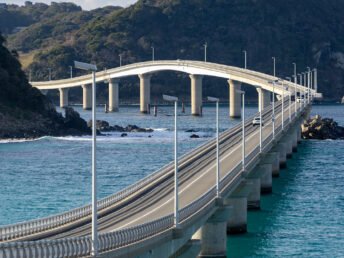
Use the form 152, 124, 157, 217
302, 115, 344, 140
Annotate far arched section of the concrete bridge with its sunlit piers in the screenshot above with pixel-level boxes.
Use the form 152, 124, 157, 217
31, 60, 314, 118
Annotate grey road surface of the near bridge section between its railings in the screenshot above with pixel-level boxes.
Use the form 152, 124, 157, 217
15, 98, 294, 241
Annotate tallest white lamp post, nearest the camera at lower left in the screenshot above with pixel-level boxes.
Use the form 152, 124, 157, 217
74, 61, 98, 256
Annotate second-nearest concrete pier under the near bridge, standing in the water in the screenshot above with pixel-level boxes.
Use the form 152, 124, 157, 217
224, 180, 252, 234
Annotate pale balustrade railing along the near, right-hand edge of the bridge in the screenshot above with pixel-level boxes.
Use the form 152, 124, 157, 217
0, 101, 307, 258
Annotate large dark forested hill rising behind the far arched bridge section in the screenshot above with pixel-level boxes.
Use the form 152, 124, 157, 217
5, 0, 344, 101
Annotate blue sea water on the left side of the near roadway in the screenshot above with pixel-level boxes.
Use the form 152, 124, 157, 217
0, 105, 257, 225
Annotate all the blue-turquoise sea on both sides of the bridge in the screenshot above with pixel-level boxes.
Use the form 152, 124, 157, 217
0, 105, 344, 257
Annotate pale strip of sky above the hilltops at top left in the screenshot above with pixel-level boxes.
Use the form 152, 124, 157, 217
0, 0, 137, 10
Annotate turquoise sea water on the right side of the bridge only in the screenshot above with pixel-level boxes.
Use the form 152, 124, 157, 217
227, 105, 344, 257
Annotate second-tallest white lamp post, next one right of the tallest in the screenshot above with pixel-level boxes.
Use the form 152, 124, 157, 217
162, 95, 179, 228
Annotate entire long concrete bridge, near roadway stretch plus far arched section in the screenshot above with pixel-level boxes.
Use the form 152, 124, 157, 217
0, 60, 318, 257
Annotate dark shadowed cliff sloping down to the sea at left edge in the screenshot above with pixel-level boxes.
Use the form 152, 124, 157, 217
0, 34, 91, 139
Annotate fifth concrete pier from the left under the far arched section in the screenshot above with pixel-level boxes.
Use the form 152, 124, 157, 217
189, 74, 203, 116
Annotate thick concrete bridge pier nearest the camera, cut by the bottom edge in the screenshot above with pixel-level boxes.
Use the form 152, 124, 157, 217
192, 205, 232, 257
